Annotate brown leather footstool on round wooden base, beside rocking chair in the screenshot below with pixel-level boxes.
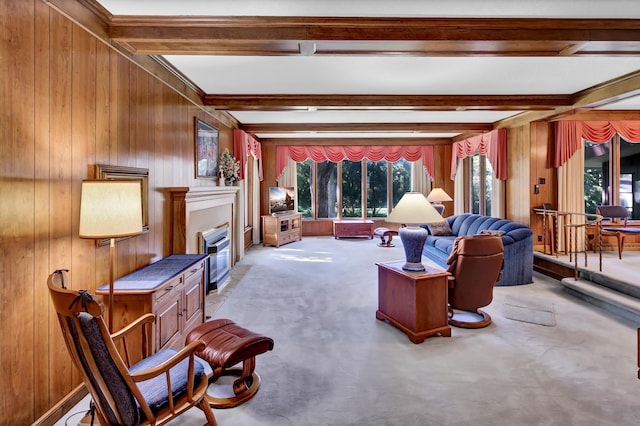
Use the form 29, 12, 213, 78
185, 319, 273, 408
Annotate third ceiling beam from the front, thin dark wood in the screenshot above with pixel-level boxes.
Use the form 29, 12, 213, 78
240, 123, 493, 134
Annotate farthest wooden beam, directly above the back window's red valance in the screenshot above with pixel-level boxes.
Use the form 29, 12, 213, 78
260, 137, 451, 146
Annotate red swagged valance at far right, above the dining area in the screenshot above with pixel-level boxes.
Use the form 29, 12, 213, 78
553, 120, 640, 167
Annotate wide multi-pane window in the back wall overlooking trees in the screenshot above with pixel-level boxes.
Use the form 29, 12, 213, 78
296, 159, 411, 219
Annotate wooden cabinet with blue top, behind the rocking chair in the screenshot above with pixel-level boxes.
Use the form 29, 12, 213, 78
96, 254, 207, 362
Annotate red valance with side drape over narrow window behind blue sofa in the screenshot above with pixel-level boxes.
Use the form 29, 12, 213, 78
451, 129, 507, 180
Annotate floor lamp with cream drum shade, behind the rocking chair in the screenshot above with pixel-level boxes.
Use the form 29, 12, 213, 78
79, 180, 142, 332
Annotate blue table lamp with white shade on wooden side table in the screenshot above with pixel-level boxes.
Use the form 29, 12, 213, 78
387, 192, 444, 271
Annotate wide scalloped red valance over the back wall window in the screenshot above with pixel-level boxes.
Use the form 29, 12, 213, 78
276, 145, 434, 177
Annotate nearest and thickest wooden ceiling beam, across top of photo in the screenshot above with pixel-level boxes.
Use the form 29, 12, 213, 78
110, 16, 640, 55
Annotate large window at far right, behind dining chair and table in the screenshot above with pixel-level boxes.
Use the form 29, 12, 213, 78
584, 136, 640, 219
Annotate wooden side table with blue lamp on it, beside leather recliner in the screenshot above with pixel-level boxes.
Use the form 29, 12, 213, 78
376, 260, 451, 344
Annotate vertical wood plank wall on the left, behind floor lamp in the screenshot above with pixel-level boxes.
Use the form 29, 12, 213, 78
0, 0, 233, 425
